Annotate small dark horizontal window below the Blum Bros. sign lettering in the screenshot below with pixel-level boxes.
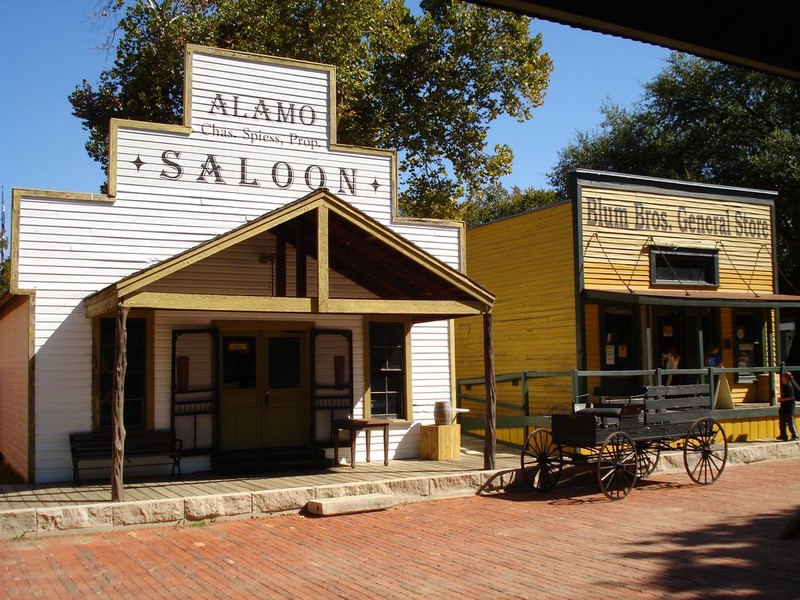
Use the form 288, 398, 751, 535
650, 247, 719, 286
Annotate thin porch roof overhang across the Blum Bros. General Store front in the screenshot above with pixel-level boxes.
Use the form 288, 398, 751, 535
583, 290, 800, 308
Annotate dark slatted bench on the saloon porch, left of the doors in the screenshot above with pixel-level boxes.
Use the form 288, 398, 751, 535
69, 429, 183, 485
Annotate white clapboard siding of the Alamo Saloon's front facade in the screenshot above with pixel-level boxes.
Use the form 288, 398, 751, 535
12, 50, 463, 481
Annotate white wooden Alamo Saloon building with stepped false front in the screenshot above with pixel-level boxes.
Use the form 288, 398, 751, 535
0, 46, 494, 482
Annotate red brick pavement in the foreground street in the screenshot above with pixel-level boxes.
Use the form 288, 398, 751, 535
0, 459, 800, 600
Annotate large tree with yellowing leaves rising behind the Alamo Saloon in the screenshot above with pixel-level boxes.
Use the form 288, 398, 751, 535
69, 0, 552, 218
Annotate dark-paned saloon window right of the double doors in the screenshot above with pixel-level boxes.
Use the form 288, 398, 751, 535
369, 322, 406, 418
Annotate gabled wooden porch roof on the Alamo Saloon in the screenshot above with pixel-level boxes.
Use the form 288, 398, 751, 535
84, 190, 494, 321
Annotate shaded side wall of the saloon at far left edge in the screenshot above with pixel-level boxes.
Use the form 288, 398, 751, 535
0, 303, 29, 474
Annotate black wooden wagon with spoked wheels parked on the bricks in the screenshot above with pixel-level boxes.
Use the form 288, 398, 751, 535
521, 385, 728, 500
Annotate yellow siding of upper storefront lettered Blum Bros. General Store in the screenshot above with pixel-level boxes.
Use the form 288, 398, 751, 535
581, 187, 773, 292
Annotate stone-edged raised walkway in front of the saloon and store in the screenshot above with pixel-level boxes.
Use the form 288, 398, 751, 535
0, 436, 800, 539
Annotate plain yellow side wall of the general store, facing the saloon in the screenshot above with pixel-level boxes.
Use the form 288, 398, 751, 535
455, 204, 577, 439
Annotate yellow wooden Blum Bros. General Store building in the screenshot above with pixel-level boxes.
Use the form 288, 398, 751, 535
455, 170, 800, 442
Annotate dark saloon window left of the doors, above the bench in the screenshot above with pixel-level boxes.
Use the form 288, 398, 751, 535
98, 318, 147, 428
